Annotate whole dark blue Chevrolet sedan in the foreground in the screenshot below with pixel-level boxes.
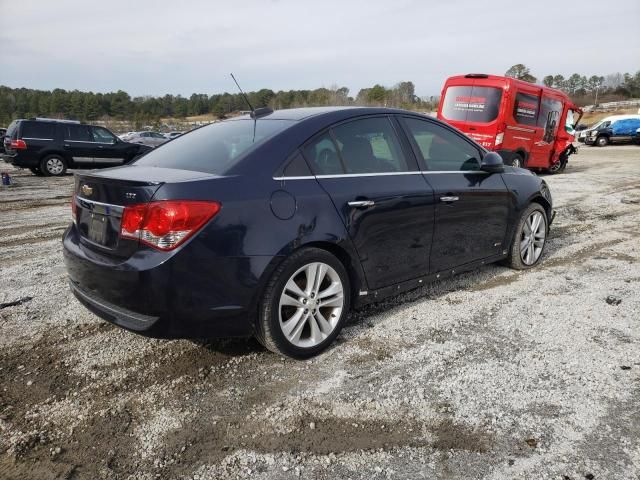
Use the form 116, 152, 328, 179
63, 107, 553, 358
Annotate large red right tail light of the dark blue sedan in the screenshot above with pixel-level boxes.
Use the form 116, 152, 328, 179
120, 200, 221, 251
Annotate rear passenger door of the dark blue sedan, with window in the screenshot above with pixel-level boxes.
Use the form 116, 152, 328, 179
304, 116, 434, 290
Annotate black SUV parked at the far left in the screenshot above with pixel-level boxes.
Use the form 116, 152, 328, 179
2, 118, 151, 176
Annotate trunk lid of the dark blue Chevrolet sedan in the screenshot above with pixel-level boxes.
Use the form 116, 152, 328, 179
74, 165, 215, 258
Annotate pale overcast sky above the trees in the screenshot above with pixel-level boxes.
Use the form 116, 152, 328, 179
0, 0, 640, 96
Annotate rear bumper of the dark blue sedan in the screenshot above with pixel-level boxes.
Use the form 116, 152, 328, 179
63, 225, 277, 338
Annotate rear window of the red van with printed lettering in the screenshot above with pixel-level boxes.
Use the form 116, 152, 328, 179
442, 86, 502, 123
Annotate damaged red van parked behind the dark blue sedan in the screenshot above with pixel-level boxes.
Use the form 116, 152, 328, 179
438, 73, 582, 173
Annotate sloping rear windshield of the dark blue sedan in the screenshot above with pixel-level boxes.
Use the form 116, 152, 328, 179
135, 119, 293, 175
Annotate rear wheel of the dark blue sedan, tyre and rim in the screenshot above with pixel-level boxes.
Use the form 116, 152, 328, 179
256, 248, 350, 358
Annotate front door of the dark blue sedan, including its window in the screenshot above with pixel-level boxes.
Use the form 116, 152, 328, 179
402, 117, 513, 273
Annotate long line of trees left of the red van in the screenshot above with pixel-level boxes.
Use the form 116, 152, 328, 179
0, 81, 438, 126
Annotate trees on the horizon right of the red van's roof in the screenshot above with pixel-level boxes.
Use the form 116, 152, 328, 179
505, 63, 640, 105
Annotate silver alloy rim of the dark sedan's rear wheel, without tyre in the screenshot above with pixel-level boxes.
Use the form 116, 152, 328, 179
278, 262, 345, 348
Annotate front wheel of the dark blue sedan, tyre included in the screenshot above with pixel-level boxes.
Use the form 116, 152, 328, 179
506, 203, 548, 270
